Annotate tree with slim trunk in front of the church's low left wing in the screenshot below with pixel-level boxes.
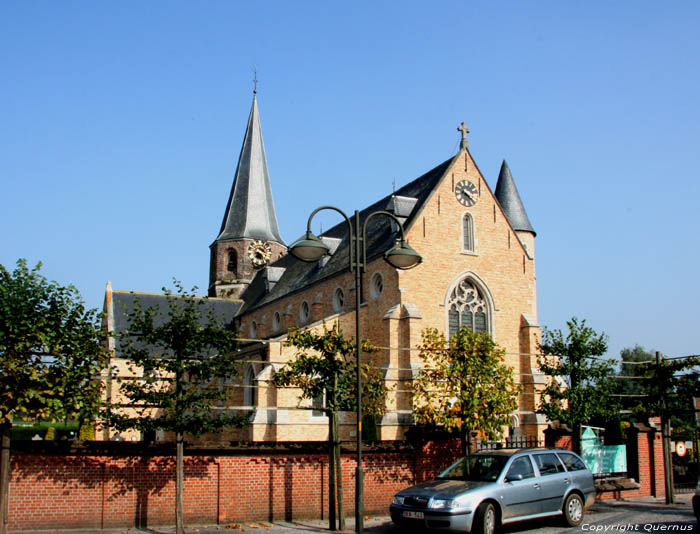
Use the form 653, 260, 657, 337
107, 281, 250, 534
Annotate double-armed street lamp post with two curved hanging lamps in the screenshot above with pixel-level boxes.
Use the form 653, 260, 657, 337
289, 206, 422, 533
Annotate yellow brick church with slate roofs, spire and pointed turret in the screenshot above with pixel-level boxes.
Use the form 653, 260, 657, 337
105, 93, 547, 442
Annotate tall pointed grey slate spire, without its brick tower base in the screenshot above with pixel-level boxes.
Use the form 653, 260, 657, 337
215, 92, 284, 245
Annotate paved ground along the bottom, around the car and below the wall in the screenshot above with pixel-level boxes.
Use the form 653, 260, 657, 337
18, 495, 700, 534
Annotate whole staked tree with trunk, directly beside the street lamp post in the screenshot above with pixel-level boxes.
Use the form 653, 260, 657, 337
272, 324, 387, 530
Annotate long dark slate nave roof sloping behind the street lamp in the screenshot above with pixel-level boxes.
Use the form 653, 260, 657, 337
241, 156, 457, 313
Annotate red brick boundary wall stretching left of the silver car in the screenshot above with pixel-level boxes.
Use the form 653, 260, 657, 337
9, 441, 459, 530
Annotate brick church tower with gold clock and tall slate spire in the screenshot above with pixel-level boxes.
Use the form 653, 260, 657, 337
209, 91, 287, 298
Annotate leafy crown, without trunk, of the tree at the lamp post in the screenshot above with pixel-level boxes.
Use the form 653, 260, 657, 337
272, 325, 387, 415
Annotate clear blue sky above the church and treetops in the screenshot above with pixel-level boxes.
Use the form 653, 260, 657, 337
0, 0, 700, 356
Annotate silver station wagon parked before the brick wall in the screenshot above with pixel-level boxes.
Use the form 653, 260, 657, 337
390, 449, 595, 534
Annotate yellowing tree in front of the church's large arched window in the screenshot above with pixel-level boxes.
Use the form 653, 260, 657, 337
413, 327, 521, 455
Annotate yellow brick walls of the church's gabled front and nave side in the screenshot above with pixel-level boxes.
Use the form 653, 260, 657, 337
235, 151, 539, 440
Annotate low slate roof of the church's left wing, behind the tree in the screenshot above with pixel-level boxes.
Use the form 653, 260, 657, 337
107, 290, 243, 356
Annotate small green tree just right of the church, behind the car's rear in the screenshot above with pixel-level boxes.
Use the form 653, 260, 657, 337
537, 317, 619, 454
